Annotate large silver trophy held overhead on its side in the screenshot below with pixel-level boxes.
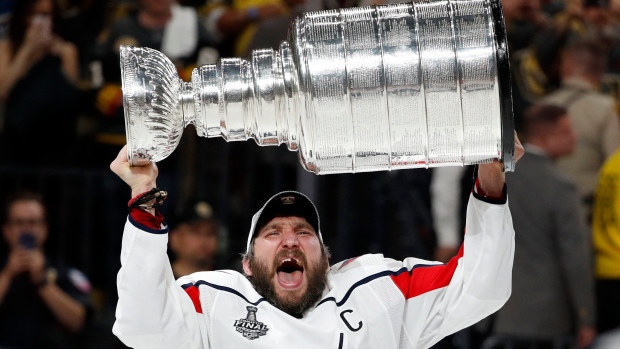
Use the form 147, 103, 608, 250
121, 0, 514, 174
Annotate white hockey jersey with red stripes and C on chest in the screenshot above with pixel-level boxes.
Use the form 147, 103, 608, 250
113, 194, 514, 349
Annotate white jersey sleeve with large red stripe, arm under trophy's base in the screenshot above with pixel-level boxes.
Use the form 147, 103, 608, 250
391, 193, 514, 348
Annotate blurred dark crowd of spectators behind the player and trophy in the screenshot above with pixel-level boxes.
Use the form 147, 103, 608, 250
0, 0, 620, 349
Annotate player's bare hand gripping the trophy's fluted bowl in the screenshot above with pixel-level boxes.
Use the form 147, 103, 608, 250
110, 145, 158, 197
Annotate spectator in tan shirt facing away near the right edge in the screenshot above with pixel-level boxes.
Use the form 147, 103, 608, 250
542, 41, 620, 219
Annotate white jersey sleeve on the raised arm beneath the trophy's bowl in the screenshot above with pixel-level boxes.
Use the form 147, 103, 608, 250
112, 216, 208, 349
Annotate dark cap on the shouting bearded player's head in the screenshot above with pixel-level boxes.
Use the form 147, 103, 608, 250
245, 190, 323, 252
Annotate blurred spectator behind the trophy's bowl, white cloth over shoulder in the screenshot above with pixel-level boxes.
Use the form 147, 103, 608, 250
96, 0, 214, 162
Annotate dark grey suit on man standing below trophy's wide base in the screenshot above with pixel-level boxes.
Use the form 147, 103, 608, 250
495, 147, 594, 341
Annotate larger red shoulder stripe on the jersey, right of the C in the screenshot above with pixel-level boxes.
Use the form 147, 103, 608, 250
390, 246, 463, 299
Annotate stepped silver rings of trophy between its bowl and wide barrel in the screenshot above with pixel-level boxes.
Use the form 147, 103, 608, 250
184, 42, 297, 150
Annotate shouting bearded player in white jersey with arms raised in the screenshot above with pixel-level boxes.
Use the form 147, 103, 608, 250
110, 137, 523, 349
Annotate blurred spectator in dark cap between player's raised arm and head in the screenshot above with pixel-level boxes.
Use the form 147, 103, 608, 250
170, 201, 224, 278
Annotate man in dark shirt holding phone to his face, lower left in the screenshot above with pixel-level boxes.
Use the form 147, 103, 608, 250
0, 192, 90, 349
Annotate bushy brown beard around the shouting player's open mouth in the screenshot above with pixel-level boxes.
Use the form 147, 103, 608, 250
248, 246, 329, 318
